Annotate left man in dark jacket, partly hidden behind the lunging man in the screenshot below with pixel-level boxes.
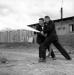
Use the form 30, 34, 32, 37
36, 18, 55, 61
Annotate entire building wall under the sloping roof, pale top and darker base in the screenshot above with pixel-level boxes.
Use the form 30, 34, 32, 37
55, 20, 74, 48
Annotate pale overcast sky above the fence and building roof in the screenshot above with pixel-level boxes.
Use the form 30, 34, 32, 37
0, 0, 74, 28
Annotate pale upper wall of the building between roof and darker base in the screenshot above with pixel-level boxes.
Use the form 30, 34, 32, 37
55, 20, 74, 35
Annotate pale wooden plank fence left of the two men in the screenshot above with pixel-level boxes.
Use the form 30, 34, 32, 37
0, 30, 34, 43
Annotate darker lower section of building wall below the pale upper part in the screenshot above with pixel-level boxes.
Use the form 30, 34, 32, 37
58, 33, 74, 48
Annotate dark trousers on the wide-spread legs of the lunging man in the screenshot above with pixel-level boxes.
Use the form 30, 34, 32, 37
39, 36, 71, 59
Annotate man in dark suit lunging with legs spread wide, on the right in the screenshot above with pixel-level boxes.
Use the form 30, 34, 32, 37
40, 16, 71, 61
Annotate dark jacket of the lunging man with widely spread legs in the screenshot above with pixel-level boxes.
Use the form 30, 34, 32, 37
43, 21, 58, 40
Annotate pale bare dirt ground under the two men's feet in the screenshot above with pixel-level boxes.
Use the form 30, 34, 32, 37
0, 48, 74, 75
